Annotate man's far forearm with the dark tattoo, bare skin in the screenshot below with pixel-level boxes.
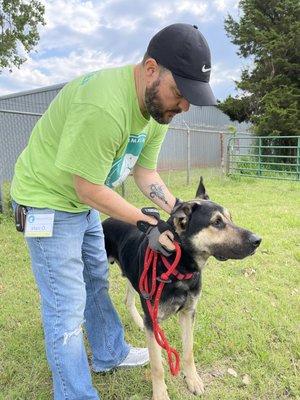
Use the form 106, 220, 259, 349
133, 165, 176, 214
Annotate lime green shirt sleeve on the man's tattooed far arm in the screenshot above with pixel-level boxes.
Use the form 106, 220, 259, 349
137, 122, 169, 169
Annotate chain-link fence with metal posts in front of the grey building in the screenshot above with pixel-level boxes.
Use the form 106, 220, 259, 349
0, 110, 249, 209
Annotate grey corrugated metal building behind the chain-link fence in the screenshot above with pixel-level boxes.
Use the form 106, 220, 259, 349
0, 84, 253, 209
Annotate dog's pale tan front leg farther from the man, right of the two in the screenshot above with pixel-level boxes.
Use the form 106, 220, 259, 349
179, 308, 204, 395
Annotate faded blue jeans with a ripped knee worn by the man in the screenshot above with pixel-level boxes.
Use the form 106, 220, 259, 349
13, 207, 129, 400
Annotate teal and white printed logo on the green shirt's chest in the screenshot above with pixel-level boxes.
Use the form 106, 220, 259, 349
105, 133, 147, 188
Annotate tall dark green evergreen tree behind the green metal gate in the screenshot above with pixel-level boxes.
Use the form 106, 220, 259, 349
219, 0, 300, 136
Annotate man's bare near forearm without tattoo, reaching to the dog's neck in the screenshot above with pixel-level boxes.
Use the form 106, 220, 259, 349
74, 175, 157, 225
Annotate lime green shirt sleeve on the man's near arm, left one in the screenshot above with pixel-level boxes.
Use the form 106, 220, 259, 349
55, 103, 122, 184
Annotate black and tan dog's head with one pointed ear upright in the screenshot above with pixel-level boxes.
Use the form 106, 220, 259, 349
171, 177, 261, 261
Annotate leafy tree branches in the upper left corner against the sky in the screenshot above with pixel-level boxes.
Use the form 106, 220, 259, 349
0, 0, 45, 73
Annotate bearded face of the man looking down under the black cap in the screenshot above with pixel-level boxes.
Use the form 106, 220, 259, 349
145, 71, 190, 124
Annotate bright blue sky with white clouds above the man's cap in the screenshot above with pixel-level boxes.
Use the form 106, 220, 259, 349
0, 0, 245, 100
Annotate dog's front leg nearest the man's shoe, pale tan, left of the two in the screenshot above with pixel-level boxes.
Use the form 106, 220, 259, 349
145, 328, 170, 400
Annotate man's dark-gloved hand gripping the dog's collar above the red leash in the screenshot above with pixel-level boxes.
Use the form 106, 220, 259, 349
137, 207, 175, 257
